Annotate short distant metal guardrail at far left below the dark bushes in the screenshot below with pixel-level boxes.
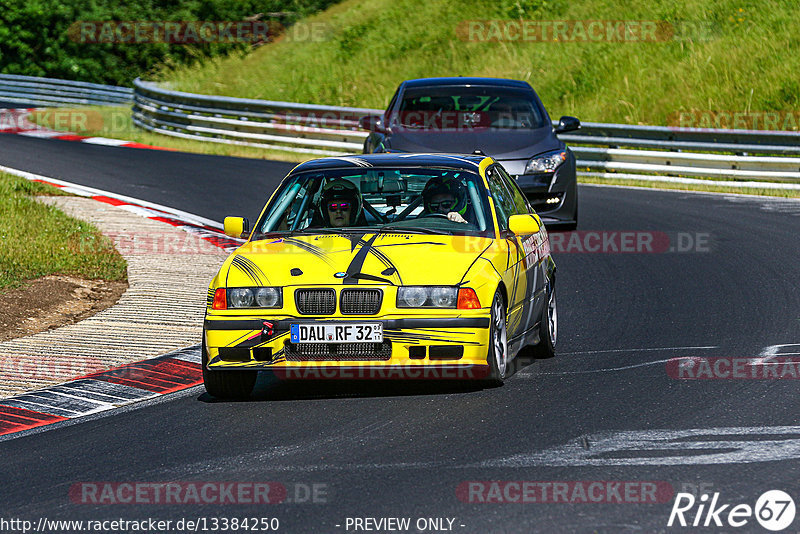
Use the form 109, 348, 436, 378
0, 74, 133, 106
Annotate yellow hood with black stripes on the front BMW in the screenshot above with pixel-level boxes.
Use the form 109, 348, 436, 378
220, 233, 493, 287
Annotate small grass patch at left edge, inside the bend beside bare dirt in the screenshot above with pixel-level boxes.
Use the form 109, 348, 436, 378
0, 173, 127, 291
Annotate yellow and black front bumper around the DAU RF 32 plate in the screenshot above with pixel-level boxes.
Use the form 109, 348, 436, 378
204, 310, 490, 379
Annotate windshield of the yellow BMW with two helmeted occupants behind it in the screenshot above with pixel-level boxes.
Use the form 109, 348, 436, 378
253, 168, 494, 239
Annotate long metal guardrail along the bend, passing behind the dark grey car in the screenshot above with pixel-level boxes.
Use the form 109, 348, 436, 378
133, 79, 800, 187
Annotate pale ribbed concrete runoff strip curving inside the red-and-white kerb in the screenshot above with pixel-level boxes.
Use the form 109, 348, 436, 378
0, 197, 227, 398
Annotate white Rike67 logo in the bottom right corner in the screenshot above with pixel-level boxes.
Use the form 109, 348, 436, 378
667, 490, 797, 532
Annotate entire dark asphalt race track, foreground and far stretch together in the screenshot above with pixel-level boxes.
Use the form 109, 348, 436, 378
0, 135, 800, 533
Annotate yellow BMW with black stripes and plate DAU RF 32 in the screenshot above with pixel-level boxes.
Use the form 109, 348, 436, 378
202, 153, 558, 398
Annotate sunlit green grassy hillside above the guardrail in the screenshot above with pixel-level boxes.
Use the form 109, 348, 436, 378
156, 0, 800, 124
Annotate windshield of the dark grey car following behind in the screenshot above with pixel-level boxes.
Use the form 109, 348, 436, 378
392, 86, 546, 130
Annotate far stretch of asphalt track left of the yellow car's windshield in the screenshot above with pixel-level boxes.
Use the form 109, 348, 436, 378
0, 135, 295, 222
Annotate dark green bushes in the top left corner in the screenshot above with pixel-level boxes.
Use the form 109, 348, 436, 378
0, 0, 334, 85
